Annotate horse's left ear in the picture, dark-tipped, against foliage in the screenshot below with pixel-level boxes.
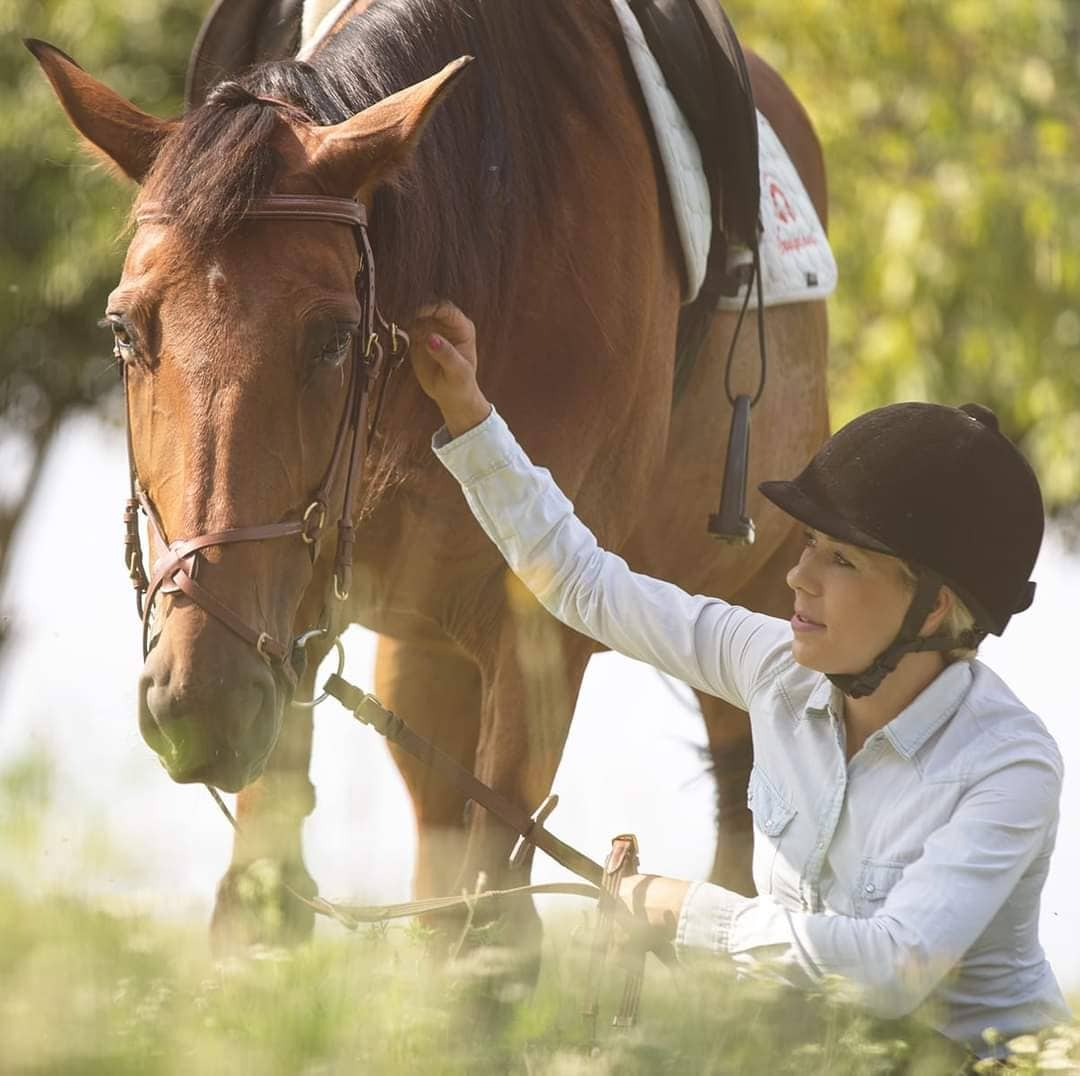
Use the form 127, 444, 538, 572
24, 38, 175, 183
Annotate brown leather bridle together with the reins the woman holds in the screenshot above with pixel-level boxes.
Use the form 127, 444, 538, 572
118, 194, 674, 1039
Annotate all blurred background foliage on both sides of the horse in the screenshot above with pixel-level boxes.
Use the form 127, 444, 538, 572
0, 0, 1080, 553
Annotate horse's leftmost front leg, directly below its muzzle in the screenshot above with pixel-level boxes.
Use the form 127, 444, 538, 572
210, 647, 324, 955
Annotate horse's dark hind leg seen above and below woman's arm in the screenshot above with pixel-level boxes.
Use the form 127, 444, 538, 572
694, 529, 802, 897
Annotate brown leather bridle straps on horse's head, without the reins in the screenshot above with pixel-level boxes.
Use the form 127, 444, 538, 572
120, 194, 409, 691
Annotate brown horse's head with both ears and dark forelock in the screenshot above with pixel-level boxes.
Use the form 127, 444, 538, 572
27, 41, 467, 791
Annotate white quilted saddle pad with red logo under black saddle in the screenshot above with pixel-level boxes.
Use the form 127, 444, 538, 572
297, 0, 837, 309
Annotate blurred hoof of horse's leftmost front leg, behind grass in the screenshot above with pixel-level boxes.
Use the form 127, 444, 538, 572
210, 859, 318, 957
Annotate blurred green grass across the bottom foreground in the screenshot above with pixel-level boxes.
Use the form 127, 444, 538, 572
0, 761, 1080, 1076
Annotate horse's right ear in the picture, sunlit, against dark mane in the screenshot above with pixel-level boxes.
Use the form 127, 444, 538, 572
311, 56, 473, 201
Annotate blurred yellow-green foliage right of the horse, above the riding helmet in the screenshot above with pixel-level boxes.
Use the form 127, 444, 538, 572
726, 0, 1080, 509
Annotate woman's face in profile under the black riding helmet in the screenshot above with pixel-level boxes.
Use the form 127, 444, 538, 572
787, 528, 912, 673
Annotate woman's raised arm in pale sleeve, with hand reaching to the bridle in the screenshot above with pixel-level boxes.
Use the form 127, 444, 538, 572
411, 304, 791, 709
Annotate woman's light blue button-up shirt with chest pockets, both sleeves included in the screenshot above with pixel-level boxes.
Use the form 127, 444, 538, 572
432, 411, 1069, 1053
